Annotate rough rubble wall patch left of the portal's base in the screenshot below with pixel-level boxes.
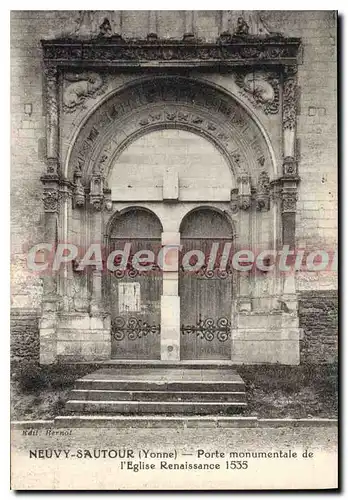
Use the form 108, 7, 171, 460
11, 308, 40, 362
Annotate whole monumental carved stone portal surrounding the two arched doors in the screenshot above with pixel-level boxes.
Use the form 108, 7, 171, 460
13, 11, 335, 364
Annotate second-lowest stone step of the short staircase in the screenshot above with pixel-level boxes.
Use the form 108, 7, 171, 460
70, 389, 246, 402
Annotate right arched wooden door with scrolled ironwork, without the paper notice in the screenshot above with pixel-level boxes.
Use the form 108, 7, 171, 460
180, 210, 233, 360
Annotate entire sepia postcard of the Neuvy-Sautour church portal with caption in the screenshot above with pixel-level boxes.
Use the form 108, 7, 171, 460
11, 10, 338, 490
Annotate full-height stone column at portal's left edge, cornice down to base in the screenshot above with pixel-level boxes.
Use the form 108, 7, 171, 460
39, 66, 59, 364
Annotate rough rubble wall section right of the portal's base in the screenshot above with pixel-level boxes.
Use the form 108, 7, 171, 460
299, 291, 338, 364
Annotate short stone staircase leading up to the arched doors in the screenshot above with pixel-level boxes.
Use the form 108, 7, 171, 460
65, 365, 246, 415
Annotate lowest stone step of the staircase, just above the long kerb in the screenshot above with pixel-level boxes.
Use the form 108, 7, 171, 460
65, 400, 246, 415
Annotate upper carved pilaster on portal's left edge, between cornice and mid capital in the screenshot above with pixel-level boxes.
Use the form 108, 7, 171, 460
45, 65, 59, 174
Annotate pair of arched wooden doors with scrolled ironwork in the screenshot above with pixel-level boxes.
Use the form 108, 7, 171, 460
107, 209, 233, 360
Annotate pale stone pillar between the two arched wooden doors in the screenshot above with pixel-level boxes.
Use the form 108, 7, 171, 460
161, 232, 180, 361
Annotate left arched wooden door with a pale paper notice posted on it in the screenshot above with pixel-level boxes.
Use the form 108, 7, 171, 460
107, 208, 162, 359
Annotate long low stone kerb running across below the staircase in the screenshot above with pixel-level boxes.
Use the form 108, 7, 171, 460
11, 415, 338, 430
